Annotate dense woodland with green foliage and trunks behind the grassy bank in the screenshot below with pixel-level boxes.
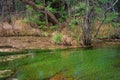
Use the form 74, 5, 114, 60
0, 0, 120, 46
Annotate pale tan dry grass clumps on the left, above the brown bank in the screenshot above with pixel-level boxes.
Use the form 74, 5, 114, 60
0, 20, 40, 36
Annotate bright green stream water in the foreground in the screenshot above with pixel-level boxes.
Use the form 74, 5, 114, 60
1, 45, 120, 80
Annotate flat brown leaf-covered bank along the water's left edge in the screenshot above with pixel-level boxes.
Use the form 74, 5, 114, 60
0, 36, 78, 52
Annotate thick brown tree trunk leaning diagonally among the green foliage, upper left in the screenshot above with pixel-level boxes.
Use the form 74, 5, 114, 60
20, 0, 59, 25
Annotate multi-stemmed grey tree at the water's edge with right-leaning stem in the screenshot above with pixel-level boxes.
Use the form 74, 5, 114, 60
76, 0, 118, 46
